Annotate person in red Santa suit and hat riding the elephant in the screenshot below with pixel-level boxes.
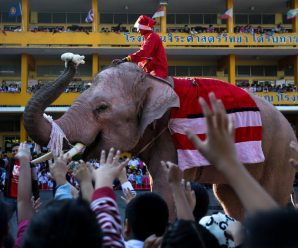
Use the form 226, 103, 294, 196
112, 15, 168, 78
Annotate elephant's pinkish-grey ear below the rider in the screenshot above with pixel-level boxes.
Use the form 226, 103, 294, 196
140, 76, 180, 134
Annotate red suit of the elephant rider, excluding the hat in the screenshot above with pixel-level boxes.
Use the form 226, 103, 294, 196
129, 31, 168, 78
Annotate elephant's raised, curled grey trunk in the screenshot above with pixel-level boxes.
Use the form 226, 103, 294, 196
24, 62, 76, 145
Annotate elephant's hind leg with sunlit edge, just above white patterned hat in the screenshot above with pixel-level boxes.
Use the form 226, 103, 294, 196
213, 184, 245, 221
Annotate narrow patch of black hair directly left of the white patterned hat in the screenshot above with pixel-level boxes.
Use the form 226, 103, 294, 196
190, 182, 209, 222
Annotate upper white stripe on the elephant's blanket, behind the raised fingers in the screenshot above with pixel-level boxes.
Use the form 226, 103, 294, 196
169, 111, 262, 134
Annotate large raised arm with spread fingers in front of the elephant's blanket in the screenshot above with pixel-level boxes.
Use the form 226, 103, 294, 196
187, 93, 278, 213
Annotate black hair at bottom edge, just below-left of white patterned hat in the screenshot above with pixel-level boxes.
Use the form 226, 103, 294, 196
161, 219, 220, 248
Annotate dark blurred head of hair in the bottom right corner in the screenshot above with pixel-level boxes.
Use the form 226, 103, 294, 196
243, 208, 298, 248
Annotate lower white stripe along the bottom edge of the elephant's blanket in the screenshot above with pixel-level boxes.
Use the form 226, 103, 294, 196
177, 141, 265, 171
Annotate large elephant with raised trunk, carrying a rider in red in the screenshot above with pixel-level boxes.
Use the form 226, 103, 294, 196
24, 54, 296, 220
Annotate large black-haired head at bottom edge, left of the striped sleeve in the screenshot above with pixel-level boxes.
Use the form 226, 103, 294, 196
22, 199, 102, 248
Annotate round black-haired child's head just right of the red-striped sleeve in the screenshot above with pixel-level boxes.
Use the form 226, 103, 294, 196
124, 192, 169, 241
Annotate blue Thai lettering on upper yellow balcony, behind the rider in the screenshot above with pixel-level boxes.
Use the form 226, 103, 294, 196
123, 33, 298, 46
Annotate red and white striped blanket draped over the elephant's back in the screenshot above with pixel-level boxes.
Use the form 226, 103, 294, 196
169, 78, 265, 170
